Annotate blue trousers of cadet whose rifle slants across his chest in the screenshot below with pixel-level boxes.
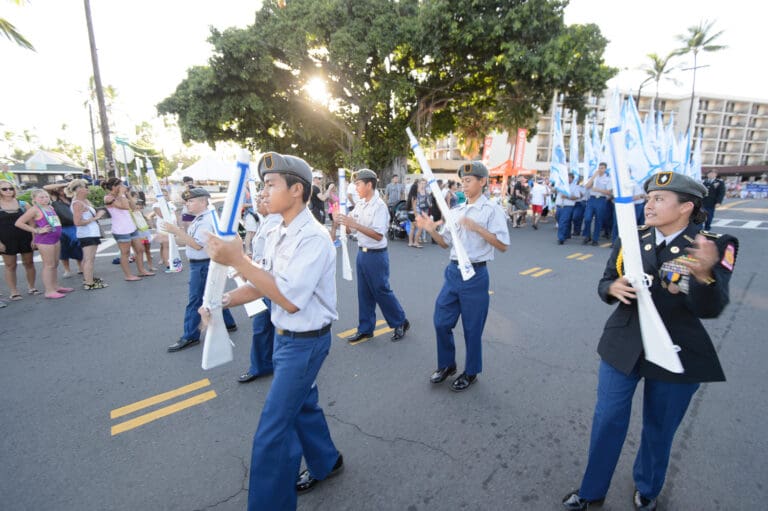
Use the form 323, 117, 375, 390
434, 263, 490, 375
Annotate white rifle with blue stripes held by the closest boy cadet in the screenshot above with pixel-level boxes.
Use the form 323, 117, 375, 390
202, 150, 251, 369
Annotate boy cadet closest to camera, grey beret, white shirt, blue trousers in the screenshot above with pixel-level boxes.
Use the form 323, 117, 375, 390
208, 152, 344, 511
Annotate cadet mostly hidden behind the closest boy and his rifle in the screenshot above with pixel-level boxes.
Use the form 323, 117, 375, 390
237, 189, 283, 383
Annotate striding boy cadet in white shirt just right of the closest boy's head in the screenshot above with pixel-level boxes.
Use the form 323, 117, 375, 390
339, 169, 411, 343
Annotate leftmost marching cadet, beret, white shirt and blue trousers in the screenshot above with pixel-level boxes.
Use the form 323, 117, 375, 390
160, 188, 237, 352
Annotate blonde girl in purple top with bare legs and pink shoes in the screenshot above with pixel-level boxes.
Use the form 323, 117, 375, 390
16, 189, 74, 299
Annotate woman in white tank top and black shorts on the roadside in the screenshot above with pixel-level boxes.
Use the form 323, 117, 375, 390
66, 179, 107, 291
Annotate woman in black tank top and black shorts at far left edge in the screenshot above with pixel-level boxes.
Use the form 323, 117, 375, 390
0, 179, 40, 301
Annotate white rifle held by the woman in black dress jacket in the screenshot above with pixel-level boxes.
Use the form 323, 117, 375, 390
608, 106, 683, 374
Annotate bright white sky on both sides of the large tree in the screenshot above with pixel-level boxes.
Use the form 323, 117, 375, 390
0, 0, 768, 160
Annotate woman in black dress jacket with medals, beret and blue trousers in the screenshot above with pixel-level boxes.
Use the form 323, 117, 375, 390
563, 172, 739, 510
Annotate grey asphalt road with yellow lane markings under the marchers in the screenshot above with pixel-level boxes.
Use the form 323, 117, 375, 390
0, 200, 768, 511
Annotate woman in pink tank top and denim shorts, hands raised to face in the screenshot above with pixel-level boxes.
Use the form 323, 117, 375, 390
101, 177, 154, 282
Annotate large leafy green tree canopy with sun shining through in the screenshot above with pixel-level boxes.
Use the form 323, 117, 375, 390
158, 0, 616, 174
